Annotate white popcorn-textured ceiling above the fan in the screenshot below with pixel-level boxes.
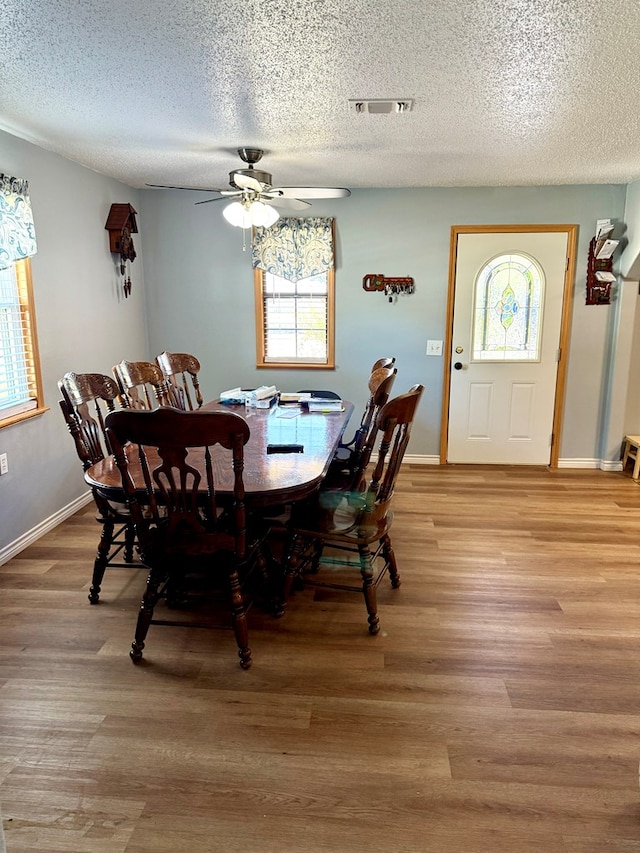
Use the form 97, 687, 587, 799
0, 0, 640, 188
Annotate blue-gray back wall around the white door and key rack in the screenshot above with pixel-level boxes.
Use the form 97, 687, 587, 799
140, 181, 625, 460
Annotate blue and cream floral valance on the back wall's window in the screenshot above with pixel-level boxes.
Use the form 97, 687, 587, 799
251, 216, 334, 281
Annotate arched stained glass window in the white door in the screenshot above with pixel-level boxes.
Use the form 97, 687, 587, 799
471, 254, 544, 361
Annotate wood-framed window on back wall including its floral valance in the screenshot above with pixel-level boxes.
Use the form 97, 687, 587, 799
252, 218, 335, 369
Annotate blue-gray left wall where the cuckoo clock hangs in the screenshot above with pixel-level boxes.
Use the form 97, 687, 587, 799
0, 126, 148, 557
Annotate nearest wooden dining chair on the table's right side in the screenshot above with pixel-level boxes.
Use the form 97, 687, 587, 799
277, 385, 424, 634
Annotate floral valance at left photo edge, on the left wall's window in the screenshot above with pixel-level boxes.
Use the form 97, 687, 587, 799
0, 174, 37, 269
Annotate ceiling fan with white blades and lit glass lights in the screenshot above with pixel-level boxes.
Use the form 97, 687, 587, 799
147, 148, 351, 228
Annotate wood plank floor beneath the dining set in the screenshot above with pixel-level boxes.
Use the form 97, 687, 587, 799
0, 466, 640, 853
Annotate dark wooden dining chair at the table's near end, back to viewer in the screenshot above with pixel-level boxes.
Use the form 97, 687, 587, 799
106, 408, 267, 669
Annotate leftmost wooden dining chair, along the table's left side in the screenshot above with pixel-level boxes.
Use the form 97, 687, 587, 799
58, 373, 139, 604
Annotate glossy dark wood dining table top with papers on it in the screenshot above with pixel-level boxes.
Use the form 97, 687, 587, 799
85, 401, 353, 506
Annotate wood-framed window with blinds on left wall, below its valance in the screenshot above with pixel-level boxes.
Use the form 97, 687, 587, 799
0, 258, 45, 427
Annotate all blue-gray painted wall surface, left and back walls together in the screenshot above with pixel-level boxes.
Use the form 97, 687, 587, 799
0, 123, 626, 562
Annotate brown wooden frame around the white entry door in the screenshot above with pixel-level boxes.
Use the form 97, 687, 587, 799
440, 225, 578, 468
